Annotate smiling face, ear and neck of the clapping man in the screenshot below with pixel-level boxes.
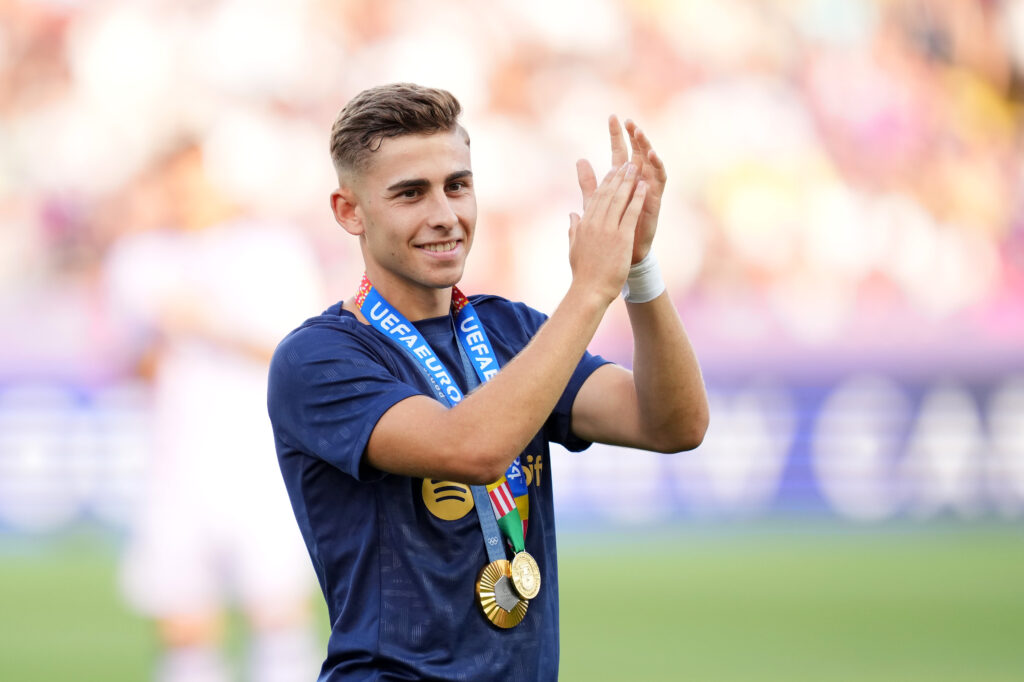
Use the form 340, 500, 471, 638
331, 127, 476, 319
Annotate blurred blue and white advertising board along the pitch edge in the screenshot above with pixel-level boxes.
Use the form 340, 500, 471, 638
0, 372, 1024, 534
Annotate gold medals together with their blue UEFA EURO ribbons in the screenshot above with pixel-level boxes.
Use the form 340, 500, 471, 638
355, 274, 541, 628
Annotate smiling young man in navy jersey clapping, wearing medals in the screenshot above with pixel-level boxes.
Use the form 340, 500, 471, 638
268, 84, 708, 681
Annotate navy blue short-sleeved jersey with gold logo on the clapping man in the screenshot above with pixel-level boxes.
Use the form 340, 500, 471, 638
268, 296, 605, 682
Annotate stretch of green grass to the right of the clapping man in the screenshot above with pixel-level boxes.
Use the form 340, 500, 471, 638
559, 526, 1024, 682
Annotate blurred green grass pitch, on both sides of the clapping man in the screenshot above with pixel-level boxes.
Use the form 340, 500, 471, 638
0, 523, 1024, 682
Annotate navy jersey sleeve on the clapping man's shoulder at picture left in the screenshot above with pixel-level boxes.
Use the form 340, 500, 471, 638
267, 326, 422, 480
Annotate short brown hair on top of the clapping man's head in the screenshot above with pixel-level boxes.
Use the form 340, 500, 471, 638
331, 83, 462, 173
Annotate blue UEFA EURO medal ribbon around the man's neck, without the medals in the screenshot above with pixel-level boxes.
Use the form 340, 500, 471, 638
355, 274, 529, 548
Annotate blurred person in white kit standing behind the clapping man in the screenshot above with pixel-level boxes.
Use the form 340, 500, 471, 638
99, 142, 321, 682
